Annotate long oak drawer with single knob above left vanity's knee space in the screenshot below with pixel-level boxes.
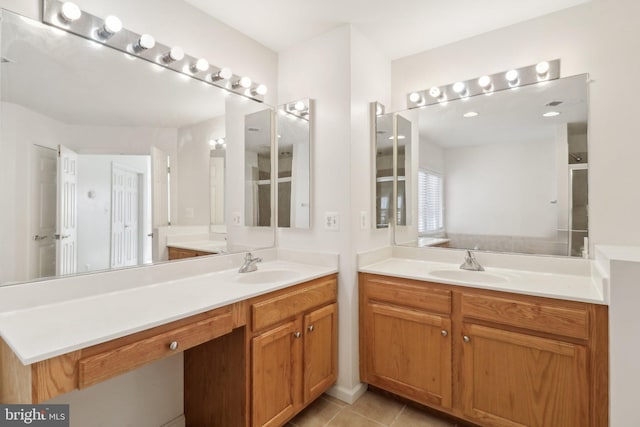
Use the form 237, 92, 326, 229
78, 308, 233, 388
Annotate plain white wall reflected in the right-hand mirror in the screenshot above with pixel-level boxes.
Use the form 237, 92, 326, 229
444, 140, 558, 238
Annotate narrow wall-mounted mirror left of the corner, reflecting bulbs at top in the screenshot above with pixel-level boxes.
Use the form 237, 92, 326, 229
277, 99, 313, 228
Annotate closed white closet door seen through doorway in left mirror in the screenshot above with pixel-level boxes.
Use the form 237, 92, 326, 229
111, 163, 140, 268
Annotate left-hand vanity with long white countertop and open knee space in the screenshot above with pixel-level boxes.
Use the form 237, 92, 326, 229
0, 255, 337, 426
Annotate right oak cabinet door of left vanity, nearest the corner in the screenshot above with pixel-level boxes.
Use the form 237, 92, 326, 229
304, 304, 338, 404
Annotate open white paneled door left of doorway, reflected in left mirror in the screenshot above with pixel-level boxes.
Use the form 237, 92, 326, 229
55, 145, 78, 275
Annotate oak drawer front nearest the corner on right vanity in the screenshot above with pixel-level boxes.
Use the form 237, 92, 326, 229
363, 275, 451, 314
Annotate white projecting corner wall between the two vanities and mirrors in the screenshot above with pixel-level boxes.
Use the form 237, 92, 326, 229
278, 26, 390, 400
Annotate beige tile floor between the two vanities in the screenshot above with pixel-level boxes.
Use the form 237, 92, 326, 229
286, 390, 468, 427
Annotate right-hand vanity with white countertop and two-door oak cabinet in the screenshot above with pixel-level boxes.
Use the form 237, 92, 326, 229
359, 252, 608, 426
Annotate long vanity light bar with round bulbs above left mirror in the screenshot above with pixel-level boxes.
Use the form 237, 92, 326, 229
42, 0, 267, 102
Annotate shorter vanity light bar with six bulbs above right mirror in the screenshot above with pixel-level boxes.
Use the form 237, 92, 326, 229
407, 59, 560, 108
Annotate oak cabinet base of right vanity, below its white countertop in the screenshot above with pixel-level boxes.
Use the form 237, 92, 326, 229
360, 273, 608, 427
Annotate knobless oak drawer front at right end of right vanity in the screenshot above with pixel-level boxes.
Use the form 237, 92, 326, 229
462, 293, 589, 340
